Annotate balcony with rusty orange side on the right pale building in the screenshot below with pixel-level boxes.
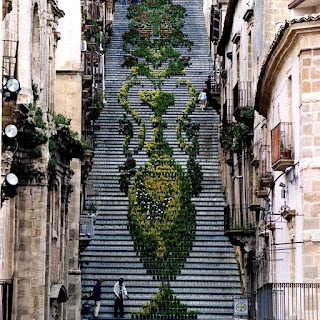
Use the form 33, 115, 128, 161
271, 122, 294, 172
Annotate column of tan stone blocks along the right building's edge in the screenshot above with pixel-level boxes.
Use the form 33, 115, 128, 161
300, 47, 320, 282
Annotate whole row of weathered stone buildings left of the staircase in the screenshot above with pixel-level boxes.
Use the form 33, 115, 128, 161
0, 0, 113, 320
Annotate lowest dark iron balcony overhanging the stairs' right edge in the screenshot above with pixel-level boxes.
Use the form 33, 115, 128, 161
224, 205, 255, 245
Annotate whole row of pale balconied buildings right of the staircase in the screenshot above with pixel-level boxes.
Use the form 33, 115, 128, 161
204, 0, 320, 319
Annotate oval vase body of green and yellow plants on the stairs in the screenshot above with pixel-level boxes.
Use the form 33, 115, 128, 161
128, 155, 196, 279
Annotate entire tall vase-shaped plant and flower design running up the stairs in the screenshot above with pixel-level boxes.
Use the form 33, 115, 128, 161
118, 0, 203, 319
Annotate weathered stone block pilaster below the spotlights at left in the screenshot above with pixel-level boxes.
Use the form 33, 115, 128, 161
14, 184, 47, 320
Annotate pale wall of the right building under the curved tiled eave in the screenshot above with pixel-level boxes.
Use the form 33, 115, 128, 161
267, 25, 320, 283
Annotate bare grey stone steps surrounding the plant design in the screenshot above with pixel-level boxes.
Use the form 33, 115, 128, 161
81, 0, 240, 320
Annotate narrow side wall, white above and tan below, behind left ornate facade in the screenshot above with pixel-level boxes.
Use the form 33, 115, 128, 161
55, 0, 82, 320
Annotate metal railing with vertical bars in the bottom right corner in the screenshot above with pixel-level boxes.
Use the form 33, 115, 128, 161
256, 283, 320, 320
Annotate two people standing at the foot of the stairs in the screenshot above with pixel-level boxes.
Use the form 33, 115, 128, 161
92, 278, 129, 318
